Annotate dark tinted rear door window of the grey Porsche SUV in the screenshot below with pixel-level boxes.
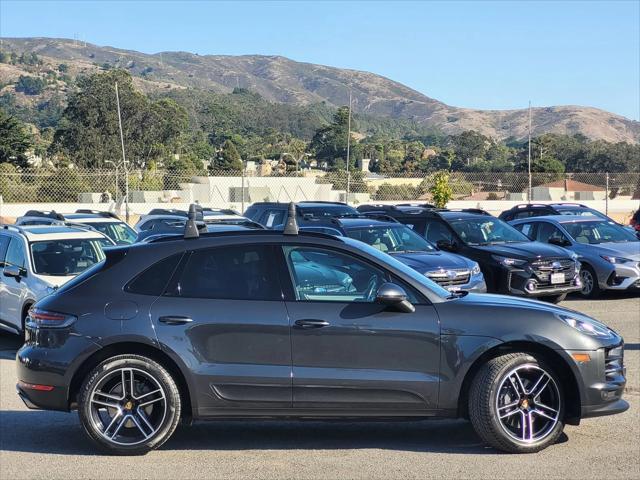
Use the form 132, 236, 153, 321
169, 245, 282, 300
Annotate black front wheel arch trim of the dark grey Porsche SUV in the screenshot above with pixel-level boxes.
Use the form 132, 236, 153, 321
458, 341, 583, 425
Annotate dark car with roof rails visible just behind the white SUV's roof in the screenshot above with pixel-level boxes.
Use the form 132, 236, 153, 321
15, 209, 136, 245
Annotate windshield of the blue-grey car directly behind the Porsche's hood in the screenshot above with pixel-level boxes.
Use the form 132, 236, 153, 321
346, 225, 436, 253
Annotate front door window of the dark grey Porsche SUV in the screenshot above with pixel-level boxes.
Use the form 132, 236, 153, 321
284, 246, 387, 303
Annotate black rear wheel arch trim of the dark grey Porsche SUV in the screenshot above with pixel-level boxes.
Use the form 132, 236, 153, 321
68, 342, 196, 423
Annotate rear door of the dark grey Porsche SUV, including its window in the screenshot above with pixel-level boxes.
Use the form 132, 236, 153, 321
150, 244, 291, 416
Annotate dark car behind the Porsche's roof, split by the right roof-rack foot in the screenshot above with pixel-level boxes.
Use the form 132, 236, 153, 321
244, 202, 359, 230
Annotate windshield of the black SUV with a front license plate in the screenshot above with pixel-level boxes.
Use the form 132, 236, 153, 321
450, 217, 531, 245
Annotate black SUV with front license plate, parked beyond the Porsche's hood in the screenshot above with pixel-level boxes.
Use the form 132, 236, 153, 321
358, 205, 581, 302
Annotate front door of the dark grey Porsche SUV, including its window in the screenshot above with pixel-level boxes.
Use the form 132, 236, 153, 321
284, 245, 440, 413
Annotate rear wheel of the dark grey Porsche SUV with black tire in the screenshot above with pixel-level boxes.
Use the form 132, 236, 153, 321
78, 355, 181, 455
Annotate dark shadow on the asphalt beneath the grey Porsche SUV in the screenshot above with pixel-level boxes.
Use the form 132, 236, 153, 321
0, 410, 536, 455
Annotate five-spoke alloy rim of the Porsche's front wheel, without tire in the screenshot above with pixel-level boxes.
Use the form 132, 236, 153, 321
496, 363, 561, 444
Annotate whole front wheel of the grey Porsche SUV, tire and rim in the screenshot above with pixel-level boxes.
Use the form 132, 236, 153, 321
469, 353, 564, 453
